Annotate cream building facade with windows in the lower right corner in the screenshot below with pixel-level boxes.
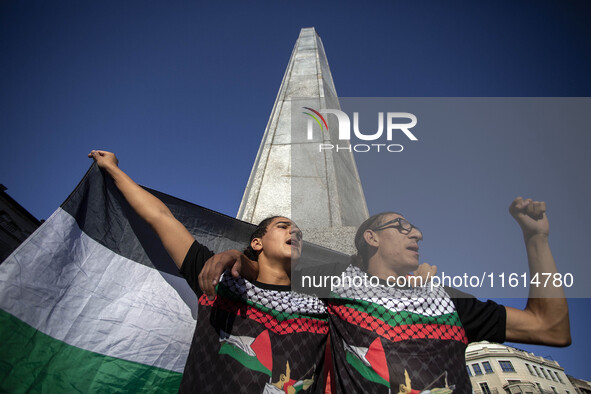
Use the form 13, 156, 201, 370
466, 342, 578, 394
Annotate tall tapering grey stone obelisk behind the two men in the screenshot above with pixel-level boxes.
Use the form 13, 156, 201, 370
237, 28, 368, 254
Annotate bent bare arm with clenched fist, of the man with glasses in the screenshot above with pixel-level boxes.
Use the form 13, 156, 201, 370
505, 197, 571, 346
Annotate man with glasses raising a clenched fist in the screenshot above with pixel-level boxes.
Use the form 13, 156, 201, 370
328, 197, 570, 393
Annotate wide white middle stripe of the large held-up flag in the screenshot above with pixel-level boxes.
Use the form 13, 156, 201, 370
0, 208, 197, 372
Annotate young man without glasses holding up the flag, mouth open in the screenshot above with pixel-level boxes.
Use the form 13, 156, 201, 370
88, 150, 328, 394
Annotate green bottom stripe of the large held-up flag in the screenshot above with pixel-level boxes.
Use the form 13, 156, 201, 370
0, 310, 182, 393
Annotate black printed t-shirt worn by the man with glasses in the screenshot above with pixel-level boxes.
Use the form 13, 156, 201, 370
328, 266, 506, 393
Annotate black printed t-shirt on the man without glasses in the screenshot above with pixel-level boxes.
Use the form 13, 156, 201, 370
179, 242, 328, 394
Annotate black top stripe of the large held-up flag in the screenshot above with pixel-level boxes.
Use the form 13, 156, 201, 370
61, 164, 254, 275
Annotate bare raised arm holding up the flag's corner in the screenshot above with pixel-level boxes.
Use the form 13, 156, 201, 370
88, 150, 195, 268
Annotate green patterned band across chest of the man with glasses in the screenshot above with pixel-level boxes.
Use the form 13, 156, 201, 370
330, 298, 462, 327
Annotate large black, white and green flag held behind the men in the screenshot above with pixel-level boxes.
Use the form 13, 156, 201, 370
0, 164, 254, 393
